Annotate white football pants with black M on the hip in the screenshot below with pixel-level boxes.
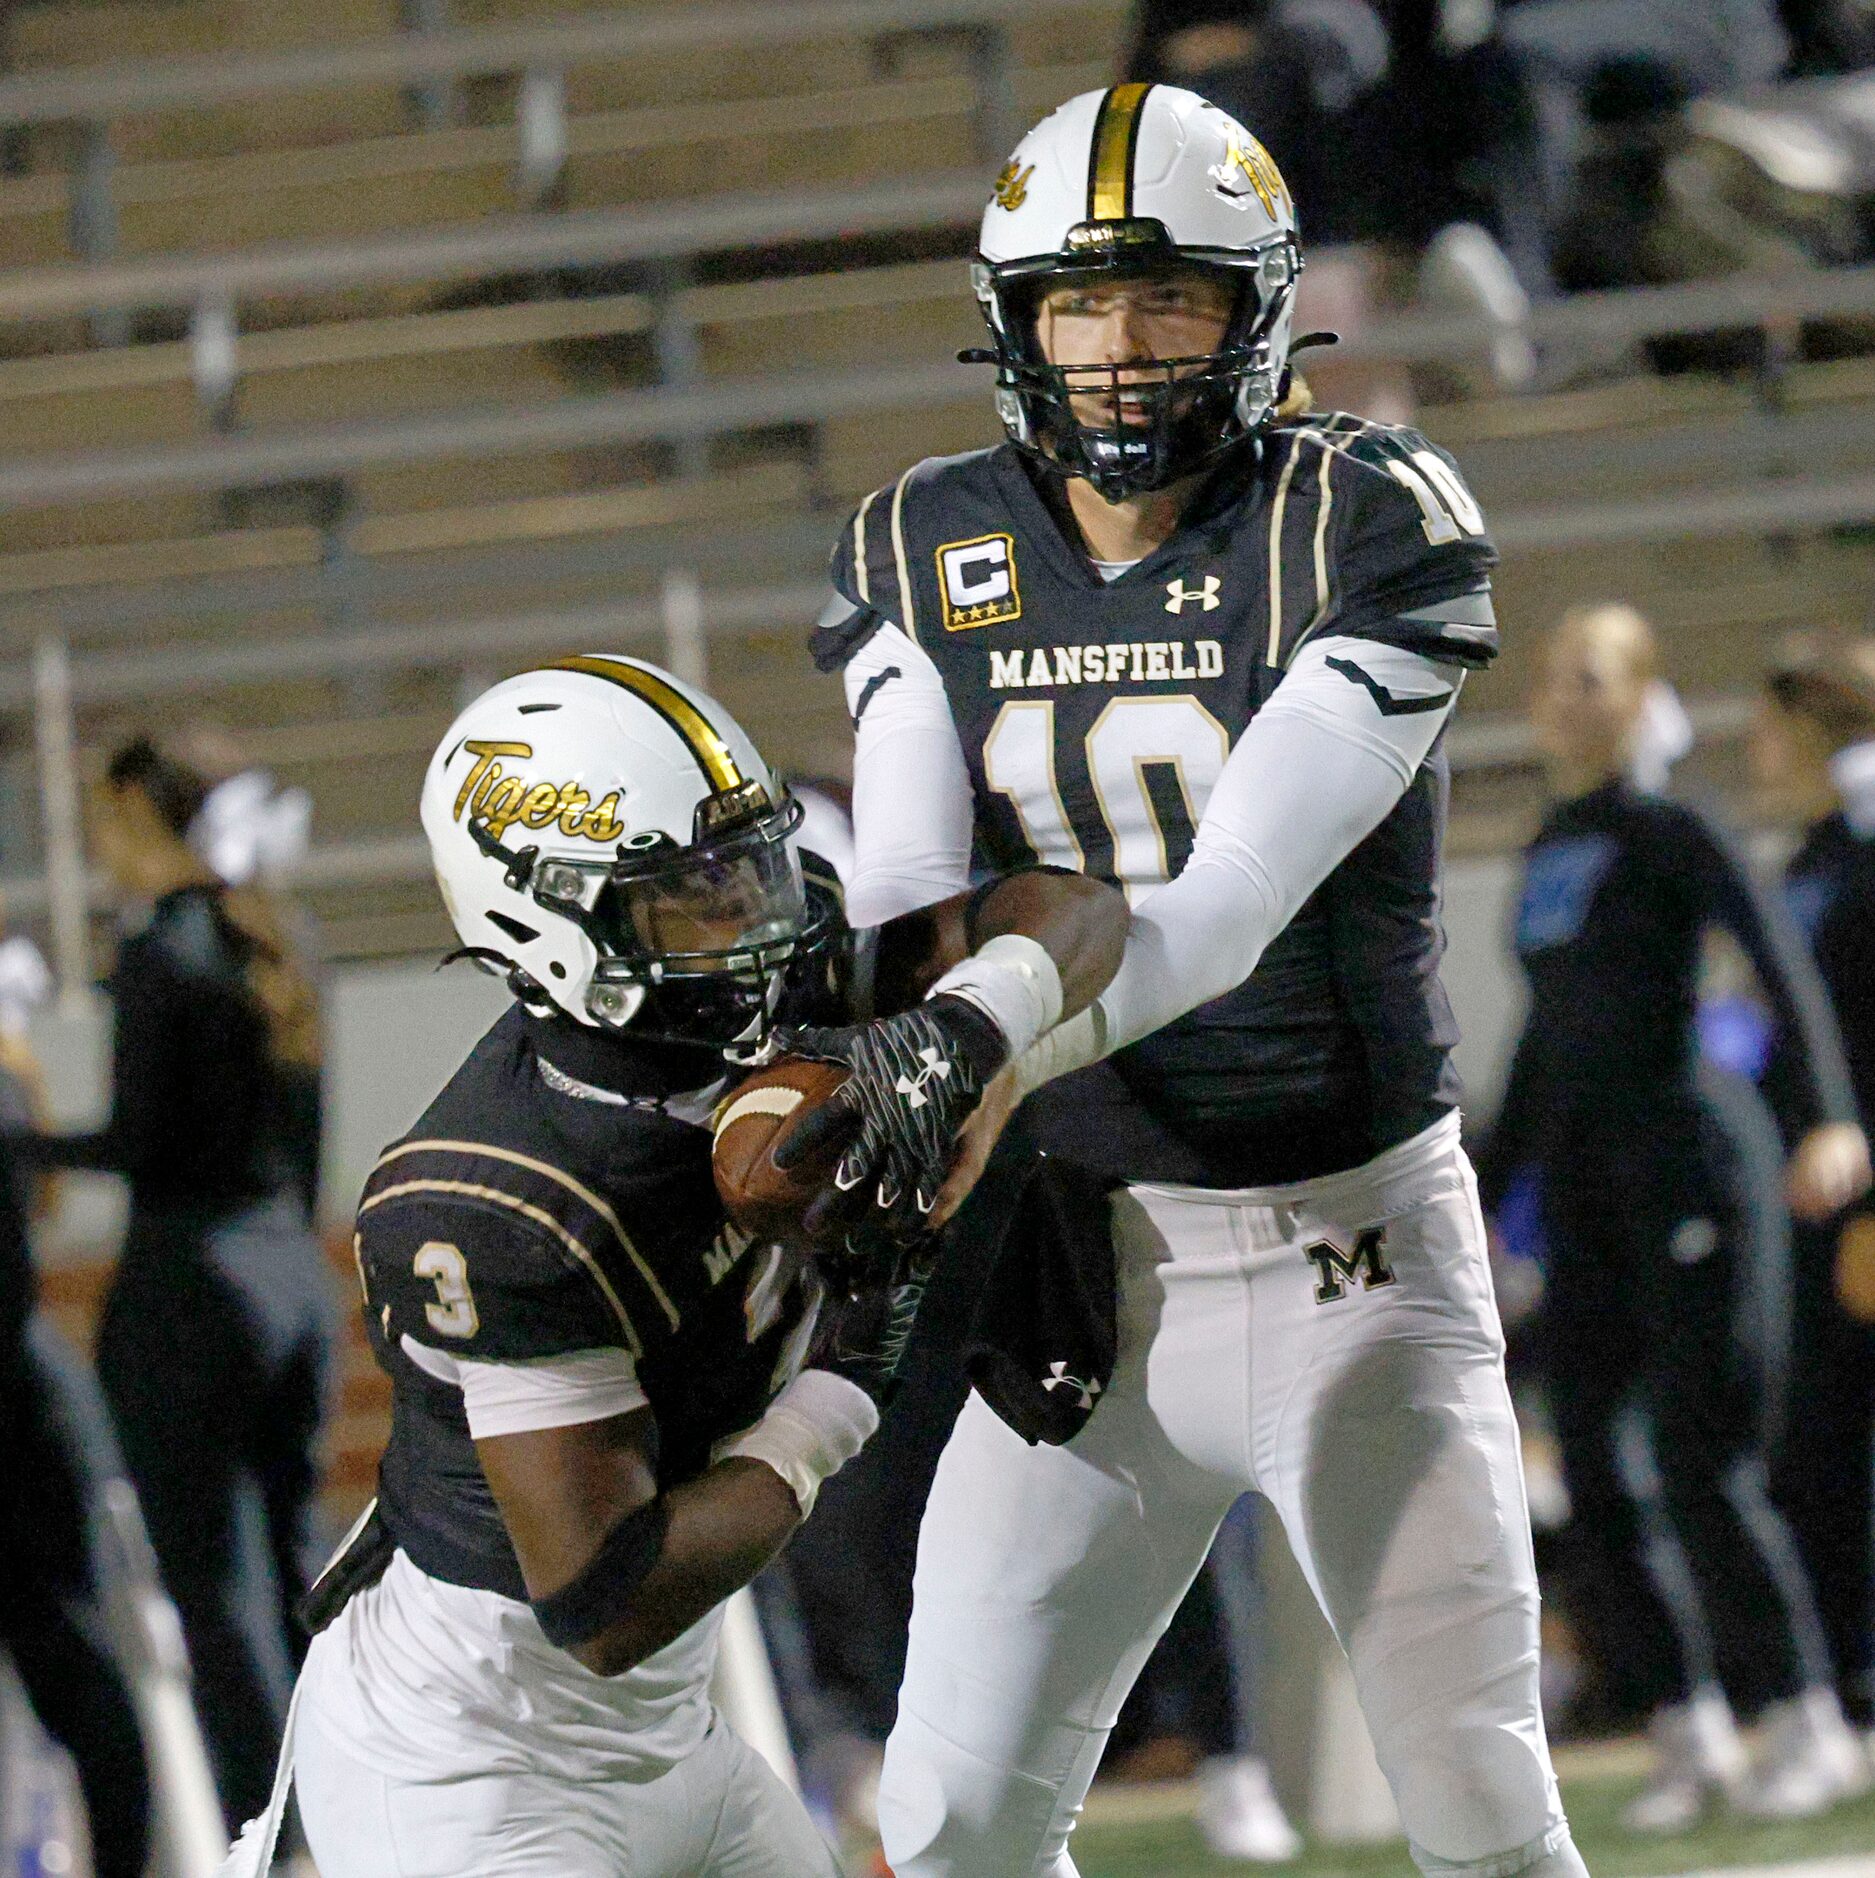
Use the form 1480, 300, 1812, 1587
879, 1116, 1582, 1878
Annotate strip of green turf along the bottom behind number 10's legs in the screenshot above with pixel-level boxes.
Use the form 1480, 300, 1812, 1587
1075, 1778, 1875, 1878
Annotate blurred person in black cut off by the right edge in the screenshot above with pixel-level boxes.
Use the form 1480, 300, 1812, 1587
1751, 642, 1875, 1728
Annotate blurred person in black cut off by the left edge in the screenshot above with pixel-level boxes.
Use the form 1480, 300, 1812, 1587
0, 939, 150, 1878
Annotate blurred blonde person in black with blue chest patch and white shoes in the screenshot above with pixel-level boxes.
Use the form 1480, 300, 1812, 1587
1480, 607, 1869, 1829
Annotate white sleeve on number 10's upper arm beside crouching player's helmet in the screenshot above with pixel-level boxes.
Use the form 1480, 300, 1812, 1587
845, 625, 975, 926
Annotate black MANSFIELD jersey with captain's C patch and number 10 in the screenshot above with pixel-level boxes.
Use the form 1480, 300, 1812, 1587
815, 415, 1497, 1187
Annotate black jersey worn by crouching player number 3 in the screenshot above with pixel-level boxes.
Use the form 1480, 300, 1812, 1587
355, 1007, 817, 1598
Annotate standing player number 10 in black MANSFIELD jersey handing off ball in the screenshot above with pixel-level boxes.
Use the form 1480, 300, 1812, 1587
815, 85, 1582, 1878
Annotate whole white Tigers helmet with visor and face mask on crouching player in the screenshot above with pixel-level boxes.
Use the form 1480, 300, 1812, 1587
423, 654, 827, 1050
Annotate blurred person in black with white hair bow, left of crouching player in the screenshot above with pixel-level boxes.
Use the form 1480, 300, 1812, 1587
15, 738, 336, 1829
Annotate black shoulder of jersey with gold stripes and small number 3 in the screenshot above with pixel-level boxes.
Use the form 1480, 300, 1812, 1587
359, 1138, 678, 1360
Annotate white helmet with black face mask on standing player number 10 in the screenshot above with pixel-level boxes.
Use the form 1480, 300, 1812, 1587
964, 85, 1302, 498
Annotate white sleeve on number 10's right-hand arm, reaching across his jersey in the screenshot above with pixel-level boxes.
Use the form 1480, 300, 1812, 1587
1016, 637, 1462, 1089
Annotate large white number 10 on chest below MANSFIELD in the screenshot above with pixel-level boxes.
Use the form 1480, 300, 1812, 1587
983, 693, 1231, 898
